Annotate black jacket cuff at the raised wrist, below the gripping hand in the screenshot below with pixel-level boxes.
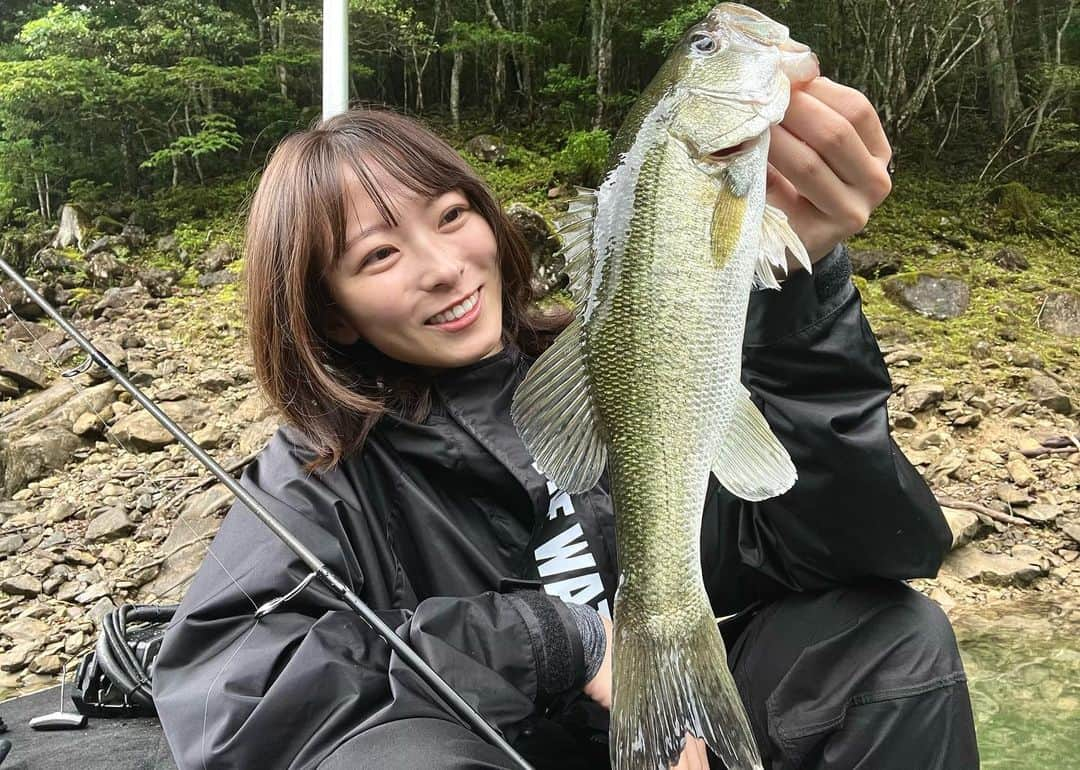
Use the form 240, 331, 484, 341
743, 243, 855, 347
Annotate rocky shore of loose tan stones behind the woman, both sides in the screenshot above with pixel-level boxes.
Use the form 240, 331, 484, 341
0, 200, 1080, 698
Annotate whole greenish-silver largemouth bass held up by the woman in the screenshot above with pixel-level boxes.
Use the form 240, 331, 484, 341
512, 3, 818, 770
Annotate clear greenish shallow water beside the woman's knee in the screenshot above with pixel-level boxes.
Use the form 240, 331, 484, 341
955, 607, 1080, 770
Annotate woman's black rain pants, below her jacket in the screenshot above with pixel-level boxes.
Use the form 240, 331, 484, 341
320, 580, 978, 770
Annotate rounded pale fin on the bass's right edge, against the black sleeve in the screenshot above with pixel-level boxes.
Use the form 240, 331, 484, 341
713, 386, 798, 501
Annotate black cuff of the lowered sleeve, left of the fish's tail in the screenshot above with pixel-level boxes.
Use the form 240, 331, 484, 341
504, 591, 585, 695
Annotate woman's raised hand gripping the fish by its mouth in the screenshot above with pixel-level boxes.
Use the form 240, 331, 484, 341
766, 77, 892, 265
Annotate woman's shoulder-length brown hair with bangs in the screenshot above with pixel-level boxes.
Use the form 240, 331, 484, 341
244, 108, 570, 472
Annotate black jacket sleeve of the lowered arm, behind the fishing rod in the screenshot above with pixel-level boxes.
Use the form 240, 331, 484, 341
153, 432, 585, 770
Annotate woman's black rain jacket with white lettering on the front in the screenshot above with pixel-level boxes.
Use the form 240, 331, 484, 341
153, 247, 950, 770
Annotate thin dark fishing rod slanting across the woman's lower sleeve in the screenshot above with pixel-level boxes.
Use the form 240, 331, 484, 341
0, 258, 532, 770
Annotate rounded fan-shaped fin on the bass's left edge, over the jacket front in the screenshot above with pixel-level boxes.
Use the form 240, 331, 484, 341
510, 319, 607, 492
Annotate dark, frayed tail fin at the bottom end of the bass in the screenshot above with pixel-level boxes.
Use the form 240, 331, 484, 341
610, 608, 761, 770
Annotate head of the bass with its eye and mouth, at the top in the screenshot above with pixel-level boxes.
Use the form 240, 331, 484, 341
650, 2, 818, 171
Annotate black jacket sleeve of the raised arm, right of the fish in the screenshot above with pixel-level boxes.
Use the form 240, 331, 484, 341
702, 246, 951, 614
